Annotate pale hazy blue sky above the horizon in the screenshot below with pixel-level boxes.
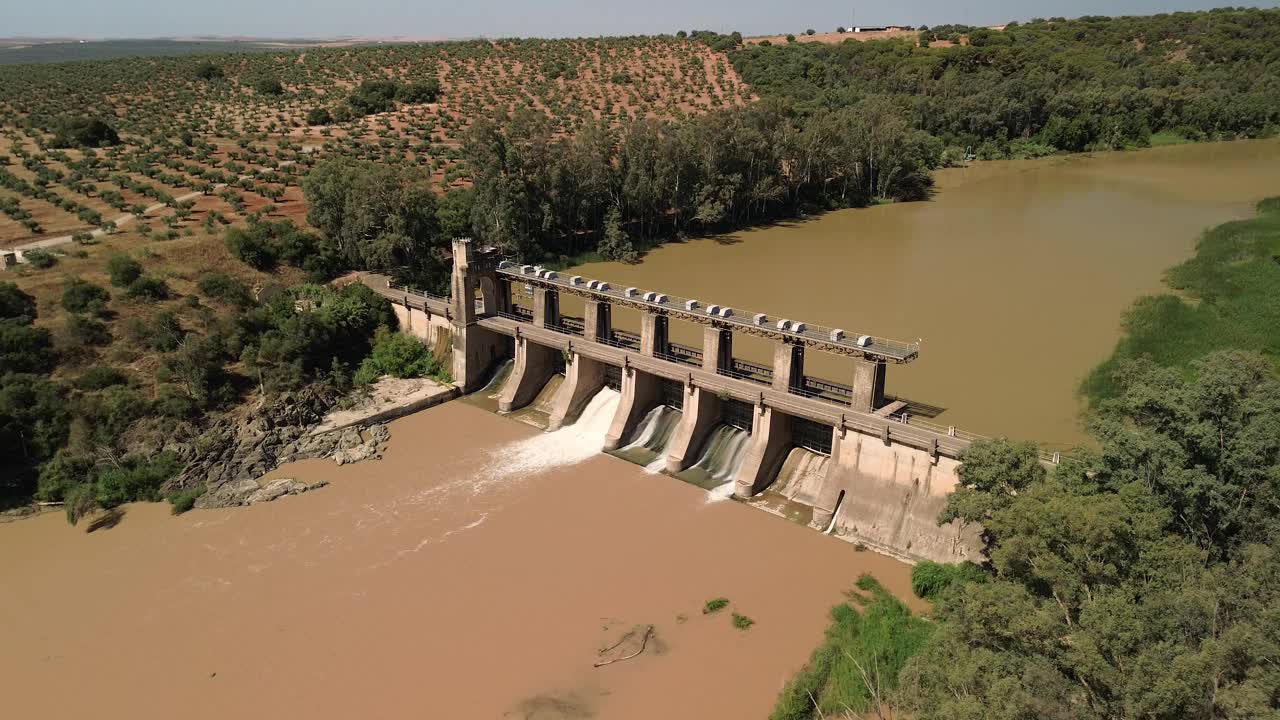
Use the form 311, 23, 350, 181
10, 0, 1280, 38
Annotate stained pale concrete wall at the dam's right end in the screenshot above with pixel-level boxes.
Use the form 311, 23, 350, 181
813, 430, 982, 562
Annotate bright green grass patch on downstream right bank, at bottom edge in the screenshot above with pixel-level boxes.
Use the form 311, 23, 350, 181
769, 575, 933, 720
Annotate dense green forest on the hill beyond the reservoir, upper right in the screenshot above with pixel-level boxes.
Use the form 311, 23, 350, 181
731, 9, 1280, 158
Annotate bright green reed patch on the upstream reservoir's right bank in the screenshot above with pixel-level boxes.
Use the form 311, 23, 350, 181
1080, 197, 1280, 402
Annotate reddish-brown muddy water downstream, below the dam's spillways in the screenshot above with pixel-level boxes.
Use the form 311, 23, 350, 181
0, 402, 910, 720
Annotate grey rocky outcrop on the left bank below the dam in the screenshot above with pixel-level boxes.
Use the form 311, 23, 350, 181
166, 388, 390, 507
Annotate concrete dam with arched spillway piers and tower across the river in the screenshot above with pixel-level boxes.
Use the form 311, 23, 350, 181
361, 240, 1056, 562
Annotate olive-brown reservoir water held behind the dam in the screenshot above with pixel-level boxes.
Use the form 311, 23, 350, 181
566, 140, 1280, 447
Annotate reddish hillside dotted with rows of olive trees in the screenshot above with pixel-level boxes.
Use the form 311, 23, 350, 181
0, 38, 750, 247
